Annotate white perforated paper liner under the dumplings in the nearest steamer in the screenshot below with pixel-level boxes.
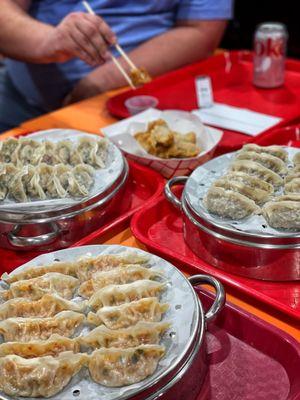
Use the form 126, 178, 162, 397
0, 245, 198, 400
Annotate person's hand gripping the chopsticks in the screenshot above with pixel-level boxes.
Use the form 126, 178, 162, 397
40, 12, 117, 66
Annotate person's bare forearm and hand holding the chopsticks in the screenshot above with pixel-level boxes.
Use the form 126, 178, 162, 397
0, 0, 116, 65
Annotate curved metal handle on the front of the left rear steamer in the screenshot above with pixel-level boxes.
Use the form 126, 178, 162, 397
7, 222, 59, 250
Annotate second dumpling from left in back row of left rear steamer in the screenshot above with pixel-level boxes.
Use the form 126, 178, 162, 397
12, 137, 42, 167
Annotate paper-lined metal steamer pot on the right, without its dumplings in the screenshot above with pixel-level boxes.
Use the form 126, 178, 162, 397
165, 149, 300, 281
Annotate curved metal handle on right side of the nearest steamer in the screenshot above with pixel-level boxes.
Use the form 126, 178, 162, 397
189, 274, 226, 322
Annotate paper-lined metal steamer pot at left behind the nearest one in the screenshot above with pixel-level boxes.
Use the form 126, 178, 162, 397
0, 130, 130, 251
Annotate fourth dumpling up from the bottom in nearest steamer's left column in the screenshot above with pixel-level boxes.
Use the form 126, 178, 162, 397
0, 294, 86, 321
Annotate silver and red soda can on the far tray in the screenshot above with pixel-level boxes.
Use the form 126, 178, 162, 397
253, 22, 288, 88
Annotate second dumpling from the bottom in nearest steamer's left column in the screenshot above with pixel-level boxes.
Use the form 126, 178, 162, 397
0, 334, 80, 358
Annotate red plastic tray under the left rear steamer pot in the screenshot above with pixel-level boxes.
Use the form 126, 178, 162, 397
0, 161, 165, 272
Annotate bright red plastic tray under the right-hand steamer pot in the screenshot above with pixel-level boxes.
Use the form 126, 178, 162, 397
131, 191, 300, 320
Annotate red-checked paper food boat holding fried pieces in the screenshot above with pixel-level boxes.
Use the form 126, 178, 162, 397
102, 109, 223, 179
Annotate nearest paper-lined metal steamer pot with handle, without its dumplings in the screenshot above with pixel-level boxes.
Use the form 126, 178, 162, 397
0, 245, 225, 400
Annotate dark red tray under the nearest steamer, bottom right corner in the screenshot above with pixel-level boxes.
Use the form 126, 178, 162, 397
197, 290, 300, 400
